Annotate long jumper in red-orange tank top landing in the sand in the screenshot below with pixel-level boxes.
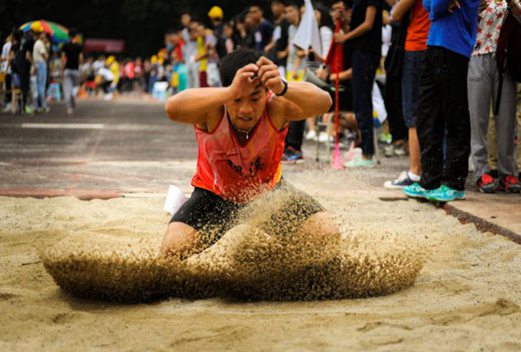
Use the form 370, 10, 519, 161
161, 49, 340, 260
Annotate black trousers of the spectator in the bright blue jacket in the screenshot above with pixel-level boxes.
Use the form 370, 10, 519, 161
417, 46, 470, 190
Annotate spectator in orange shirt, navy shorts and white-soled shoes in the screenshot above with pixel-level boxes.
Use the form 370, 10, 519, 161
385, 0, 431, 189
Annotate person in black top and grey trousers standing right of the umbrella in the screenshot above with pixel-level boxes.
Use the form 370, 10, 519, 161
62, 28, 83, 116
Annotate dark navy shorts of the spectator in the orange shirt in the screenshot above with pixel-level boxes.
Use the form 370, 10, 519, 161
402, 50, 426, 128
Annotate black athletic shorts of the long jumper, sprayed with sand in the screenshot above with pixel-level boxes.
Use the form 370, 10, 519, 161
170, 180, 324, 244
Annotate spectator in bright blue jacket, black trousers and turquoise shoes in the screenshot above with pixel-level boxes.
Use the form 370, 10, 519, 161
403, 0, 479, 202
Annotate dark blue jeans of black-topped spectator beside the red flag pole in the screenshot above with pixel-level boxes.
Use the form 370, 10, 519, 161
353, 50, 380, 157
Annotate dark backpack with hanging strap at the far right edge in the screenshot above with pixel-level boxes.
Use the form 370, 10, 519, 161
494, 12, 521, 115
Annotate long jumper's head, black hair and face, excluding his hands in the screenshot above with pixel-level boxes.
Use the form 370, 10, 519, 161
220, 49, 268, 131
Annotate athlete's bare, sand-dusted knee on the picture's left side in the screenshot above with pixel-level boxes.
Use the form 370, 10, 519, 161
160, 222, 207, 259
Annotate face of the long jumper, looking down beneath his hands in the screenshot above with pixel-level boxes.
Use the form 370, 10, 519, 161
226, 83, 267, 131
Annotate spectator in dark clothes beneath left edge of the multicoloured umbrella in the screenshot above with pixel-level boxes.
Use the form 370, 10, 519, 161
14, 22, 39, 114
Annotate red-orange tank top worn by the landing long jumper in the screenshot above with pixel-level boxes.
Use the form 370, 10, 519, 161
192, 97, 288, 203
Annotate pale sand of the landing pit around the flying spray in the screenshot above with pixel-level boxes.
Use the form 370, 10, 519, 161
0, 171, 521, 351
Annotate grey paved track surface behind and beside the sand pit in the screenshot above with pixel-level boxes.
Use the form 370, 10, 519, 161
0, 99, 521, 241
